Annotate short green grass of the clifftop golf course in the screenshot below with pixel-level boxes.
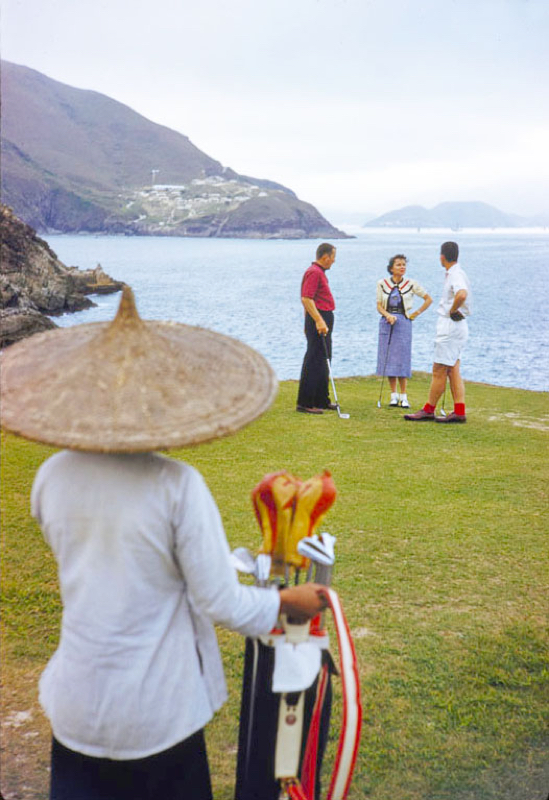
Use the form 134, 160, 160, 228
3, 375, 549, 800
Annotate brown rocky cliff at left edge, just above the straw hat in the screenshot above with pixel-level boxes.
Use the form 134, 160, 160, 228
0, 205, 123, 347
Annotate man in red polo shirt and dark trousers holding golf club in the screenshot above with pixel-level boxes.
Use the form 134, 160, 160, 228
296, 243, 336, 414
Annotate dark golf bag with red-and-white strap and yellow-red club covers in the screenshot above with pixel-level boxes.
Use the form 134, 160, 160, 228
235, 471, 361, 800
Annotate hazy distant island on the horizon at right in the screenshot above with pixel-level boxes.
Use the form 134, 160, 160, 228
362, 202, 549, 231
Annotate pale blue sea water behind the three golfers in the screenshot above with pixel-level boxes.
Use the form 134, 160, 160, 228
45, 229, 549, 391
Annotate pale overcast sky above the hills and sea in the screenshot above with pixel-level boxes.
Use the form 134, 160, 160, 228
1, 0, 549, 222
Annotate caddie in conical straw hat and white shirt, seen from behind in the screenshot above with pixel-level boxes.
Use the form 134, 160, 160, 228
2, 287, 325, 800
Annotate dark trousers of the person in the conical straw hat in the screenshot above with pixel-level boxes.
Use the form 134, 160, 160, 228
50, 731, 212, 800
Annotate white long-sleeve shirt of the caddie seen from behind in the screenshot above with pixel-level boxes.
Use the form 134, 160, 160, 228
31, 451, 279, 759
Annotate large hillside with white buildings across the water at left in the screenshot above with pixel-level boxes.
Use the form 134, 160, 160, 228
2, 61, 346, 238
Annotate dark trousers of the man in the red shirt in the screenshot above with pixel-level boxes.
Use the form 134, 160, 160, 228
297, 311, 334, 408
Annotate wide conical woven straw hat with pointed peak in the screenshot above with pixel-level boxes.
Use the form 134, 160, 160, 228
2, 287, 277, 453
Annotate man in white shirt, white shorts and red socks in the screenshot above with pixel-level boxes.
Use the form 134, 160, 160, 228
404, 242, 471, 423
